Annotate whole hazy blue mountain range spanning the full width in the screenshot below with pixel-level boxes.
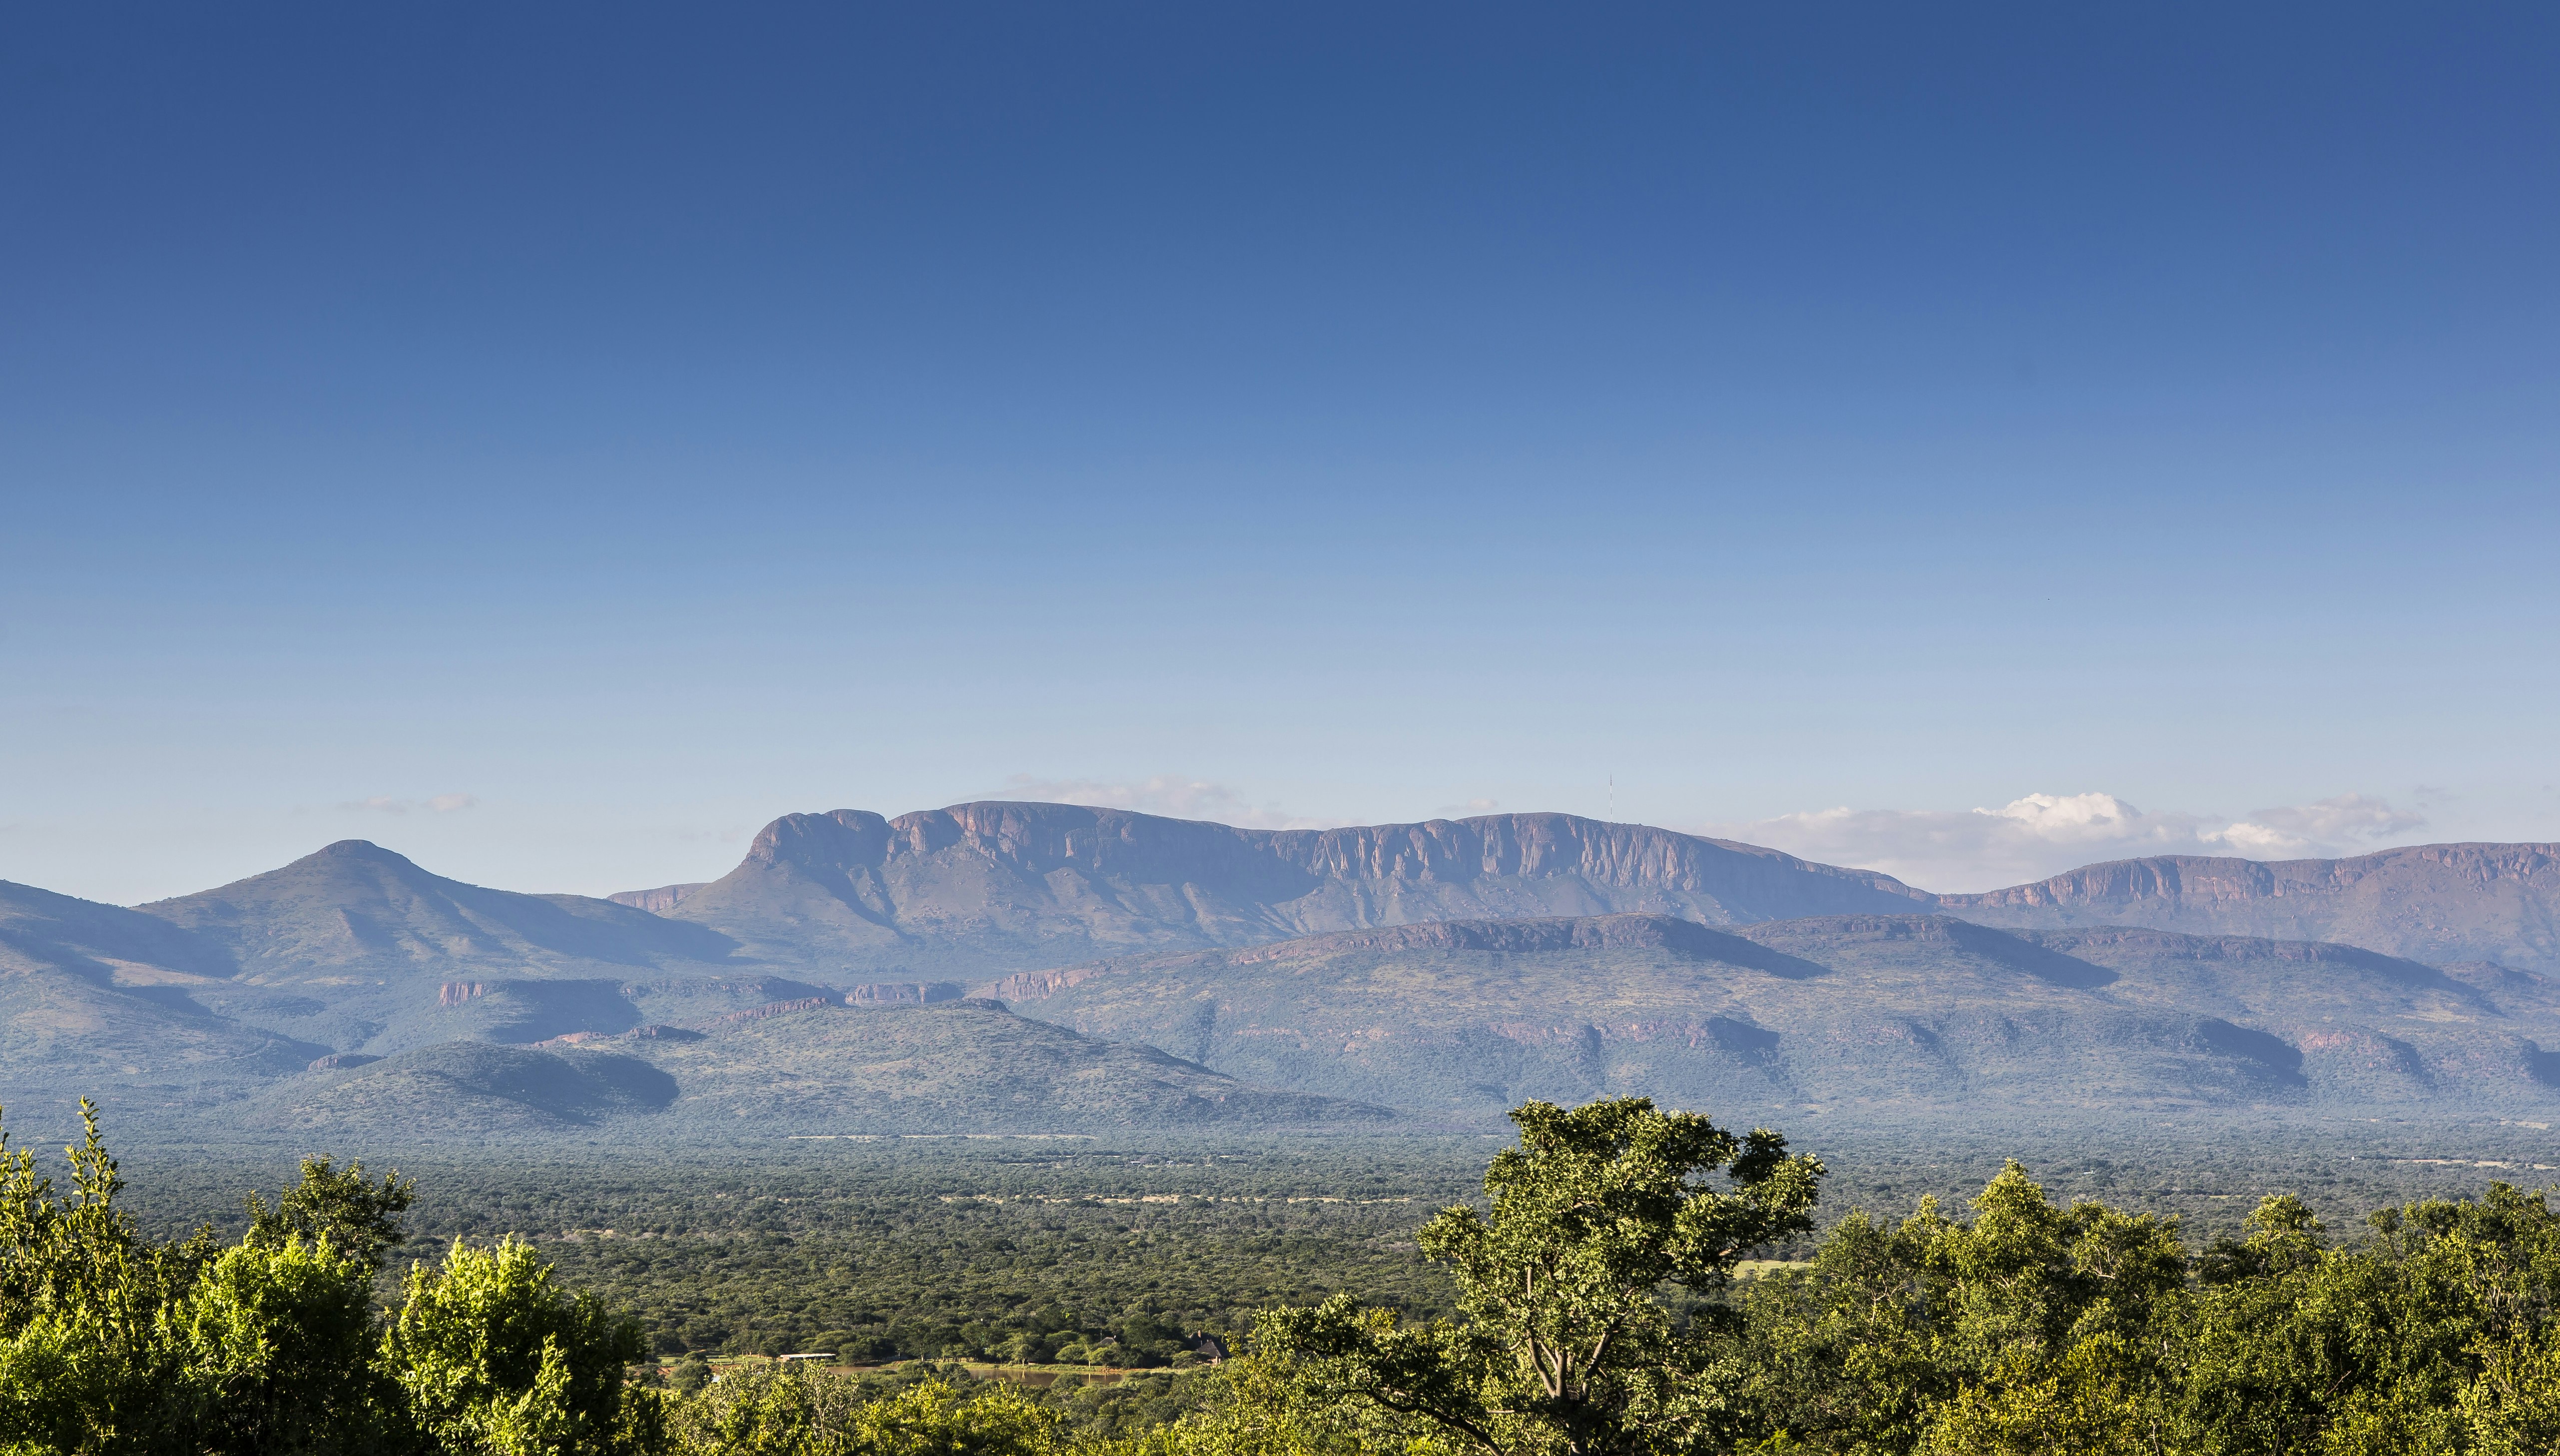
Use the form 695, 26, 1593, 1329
0, 804, 2560, 1136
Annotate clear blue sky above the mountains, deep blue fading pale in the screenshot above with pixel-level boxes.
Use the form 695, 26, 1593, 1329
0, 5, 2560, 901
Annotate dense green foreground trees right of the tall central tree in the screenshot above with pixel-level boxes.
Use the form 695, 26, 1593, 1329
1736, 1164, 2560, 1456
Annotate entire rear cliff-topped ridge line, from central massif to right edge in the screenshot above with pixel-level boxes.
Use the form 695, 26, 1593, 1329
635, 804, 2560, 975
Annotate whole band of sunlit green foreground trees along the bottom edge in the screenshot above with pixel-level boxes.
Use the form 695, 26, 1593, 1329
15, 1098, 2560, 1456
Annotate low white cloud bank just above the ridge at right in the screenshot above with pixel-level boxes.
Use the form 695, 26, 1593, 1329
1705, 793, 2427, 893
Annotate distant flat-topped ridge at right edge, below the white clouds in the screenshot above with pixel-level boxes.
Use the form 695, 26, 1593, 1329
1936, 845, 2560, 972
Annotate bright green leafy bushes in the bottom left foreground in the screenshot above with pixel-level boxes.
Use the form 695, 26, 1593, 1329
0, 1100, 666, 1456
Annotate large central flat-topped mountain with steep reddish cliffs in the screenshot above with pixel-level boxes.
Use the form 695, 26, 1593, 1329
650, 804, 1930, 970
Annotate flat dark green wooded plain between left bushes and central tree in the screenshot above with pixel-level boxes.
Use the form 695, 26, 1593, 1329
363, 1139, 1488, 1367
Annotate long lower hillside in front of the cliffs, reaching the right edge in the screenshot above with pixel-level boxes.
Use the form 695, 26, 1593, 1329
988, 916, 2560, 1121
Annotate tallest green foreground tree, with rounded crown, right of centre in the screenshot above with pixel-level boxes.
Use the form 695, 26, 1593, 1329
1254, 1098, 1823, 1456
